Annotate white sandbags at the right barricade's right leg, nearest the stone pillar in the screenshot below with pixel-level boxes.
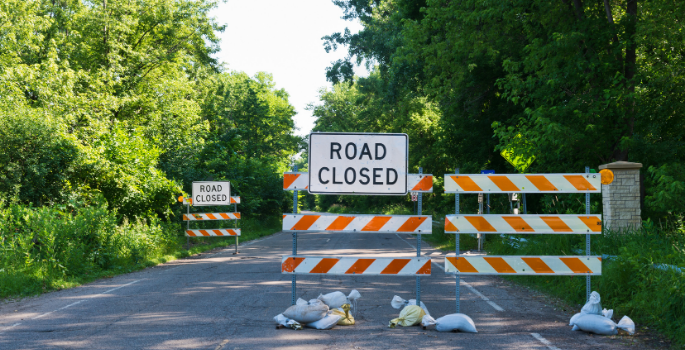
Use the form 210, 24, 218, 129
569, 292, 635, 335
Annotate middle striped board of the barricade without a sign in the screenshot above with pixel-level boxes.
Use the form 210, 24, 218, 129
445, 214, 602, 234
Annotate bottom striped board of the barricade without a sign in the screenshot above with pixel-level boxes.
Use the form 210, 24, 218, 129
445, 255, 602, 276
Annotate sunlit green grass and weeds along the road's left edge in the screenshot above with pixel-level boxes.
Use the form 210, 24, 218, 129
0, 202, 281, 299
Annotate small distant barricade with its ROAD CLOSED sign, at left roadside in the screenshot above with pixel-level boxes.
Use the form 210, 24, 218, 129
179, 181, 240, 254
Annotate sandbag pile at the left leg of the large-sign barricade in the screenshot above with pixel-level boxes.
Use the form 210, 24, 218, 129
274, 290, 361, 330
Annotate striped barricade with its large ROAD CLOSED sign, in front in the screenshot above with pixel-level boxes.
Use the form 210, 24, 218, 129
281, 133, 433, 305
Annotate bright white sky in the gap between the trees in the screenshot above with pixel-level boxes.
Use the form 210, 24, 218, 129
212, 0, 368, 135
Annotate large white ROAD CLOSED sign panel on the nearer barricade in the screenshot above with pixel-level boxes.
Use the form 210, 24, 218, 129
309, 133, 409, 195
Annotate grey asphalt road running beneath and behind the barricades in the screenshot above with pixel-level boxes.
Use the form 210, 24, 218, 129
0, 233, 644, 350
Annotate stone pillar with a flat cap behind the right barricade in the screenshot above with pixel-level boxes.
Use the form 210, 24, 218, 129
599, 161, 642, 231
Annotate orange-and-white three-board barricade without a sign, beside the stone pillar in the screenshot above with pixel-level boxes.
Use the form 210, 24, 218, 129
445, 167, 602, 312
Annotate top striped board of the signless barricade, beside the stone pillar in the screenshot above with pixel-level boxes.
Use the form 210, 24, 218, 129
445, 173, 602, 193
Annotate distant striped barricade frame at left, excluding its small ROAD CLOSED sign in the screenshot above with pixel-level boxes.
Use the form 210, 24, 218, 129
179, 196, 240, 254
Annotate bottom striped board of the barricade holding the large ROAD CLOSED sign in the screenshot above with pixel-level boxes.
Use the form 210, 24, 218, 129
281, 255, 431, 276
